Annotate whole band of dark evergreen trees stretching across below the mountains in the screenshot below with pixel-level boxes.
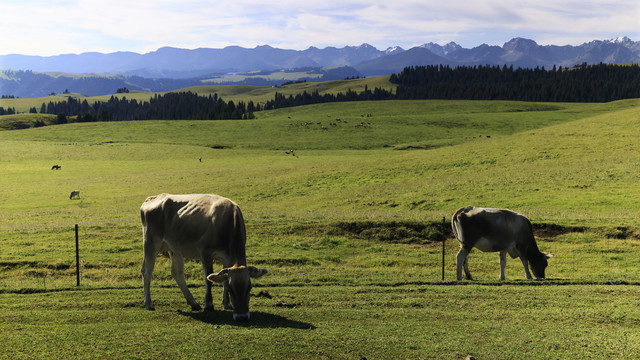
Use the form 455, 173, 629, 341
22, 64, 640, 122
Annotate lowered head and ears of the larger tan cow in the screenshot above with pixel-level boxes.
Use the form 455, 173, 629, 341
207, 265, 267, 321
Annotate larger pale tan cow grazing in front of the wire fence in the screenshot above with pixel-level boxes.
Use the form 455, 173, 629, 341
140, 194, 267, 321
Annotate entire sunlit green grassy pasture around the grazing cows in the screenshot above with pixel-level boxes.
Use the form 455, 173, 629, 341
0, 100, 640, 359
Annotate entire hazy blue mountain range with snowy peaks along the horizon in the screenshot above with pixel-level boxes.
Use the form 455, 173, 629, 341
0, 37, 640, 97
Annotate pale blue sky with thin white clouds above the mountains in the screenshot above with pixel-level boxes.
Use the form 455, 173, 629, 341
0, 0, 640, 56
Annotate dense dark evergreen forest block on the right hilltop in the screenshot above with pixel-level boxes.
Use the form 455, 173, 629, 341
390, 63, 640, 102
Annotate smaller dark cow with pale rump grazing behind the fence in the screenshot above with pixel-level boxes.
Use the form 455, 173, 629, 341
451, 206, 552, 280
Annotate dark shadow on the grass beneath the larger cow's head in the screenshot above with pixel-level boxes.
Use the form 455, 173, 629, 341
178, 310, 316, 330
